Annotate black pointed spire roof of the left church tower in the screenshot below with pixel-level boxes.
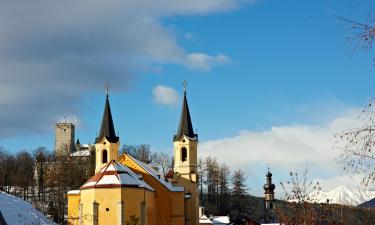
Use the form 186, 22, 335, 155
95, 94, 119, 143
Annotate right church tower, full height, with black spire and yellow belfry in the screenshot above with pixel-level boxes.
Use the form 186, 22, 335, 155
173, 81, 199, 225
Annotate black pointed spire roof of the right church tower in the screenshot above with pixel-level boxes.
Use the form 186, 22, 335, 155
173, 91, 198, 141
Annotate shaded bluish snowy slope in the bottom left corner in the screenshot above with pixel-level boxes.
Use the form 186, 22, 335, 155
0, 192, 55, 225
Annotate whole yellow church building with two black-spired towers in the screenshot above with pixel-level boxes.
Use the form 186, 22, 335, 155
67, 85, 199, 225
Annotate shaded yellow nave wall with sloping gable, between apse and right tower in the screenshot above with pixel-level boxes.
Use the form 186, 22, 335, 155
119, 154, 184, 225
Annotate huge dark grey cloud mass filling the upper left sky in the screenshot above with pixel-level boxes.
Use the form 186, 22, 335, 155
0, 0, 253, 138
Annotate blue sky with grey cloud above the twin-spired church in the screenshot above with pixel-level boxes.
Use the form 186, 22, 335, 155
0, 0, 375, 193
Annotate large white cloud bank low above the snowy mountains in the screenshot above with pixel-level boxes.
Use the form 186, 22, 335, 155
199, 110, 368, 197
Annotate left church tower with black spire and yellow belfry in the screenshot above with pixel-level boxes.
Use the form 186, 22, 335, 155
95, 87, 120, 173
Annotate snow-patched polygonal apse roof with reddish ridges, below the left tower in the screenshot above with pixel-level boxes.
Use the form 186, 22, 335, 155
81, 160, 155, 191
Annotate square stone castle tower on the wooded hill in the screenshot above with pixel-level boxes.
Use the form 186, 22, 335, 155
55, 122, 75, 157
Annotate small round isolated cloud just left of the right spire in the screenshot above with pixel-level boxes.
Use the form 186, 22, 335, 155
152, 85, 178, 105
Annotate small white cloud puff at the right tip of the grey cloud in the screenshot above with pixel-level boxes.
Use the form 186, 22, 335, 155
187, 52, 231, 71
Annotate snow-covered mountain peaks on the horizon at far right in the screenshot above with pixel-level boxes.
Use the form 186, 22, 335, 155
310, 185, 375, 206
